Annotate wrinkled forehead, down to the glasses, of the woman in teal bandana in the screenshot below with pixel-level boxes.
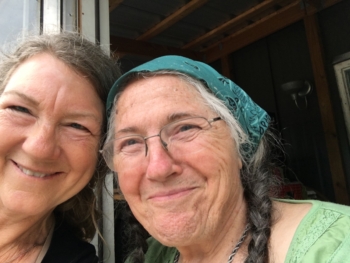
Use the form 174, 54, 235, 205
115, 75, 213, 132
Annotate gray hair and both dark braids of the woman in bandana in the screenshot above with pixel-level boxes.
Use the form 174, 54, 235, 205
107, 70, 278, 263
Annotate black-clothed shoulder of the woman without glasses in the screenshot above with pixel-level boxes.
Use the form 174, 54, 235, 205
42, 222, 98, 263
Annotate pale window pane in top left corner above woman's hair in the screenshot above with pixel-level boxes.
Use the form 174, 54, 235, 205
0, 0, 40, 45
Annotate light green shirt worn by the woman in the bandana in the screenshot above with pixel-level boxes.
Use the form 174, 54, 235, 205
126, 200, 350, 263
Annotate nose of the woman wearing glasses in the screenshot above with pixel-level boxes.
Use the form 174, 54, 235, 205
146, 139, 182, 181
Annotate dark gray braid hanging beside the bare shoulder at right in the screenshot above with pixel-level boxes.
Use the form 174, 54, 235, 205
241, 133, 279, 263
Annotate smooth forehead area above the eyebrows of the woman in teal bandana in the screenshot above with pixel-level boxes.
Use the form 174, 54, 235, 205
116, 76, 208, 121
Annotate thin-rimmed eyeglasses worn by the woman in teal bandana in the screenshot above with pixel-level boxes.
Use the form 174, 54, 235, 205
100, 117, 221, 171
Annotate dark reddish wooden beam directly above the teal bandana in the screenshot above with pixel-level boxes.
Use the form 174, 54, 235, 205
110, 36, 203, 60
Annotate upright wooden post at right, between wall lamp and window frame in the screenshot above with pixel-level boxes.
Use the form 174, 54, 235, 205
304, 15, 349, 205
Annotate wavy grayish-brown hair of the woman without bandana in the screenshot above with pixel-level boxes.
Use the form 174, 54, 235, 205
0, 32, 120, 241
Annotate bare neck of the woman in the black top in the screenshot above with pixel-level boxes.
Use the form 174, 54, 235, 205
0, 212, 54, 262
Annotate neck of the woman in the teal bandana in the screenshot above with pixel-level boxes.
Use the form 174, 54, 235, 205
177, 197, 248, 263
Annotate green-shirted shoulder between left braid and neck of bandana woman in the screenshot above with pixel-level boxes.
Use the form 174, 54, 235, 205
145, 237, 176, 263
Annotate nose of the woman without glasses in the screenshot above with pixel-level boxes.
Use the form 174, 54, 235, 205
22, 123, 60, 160
